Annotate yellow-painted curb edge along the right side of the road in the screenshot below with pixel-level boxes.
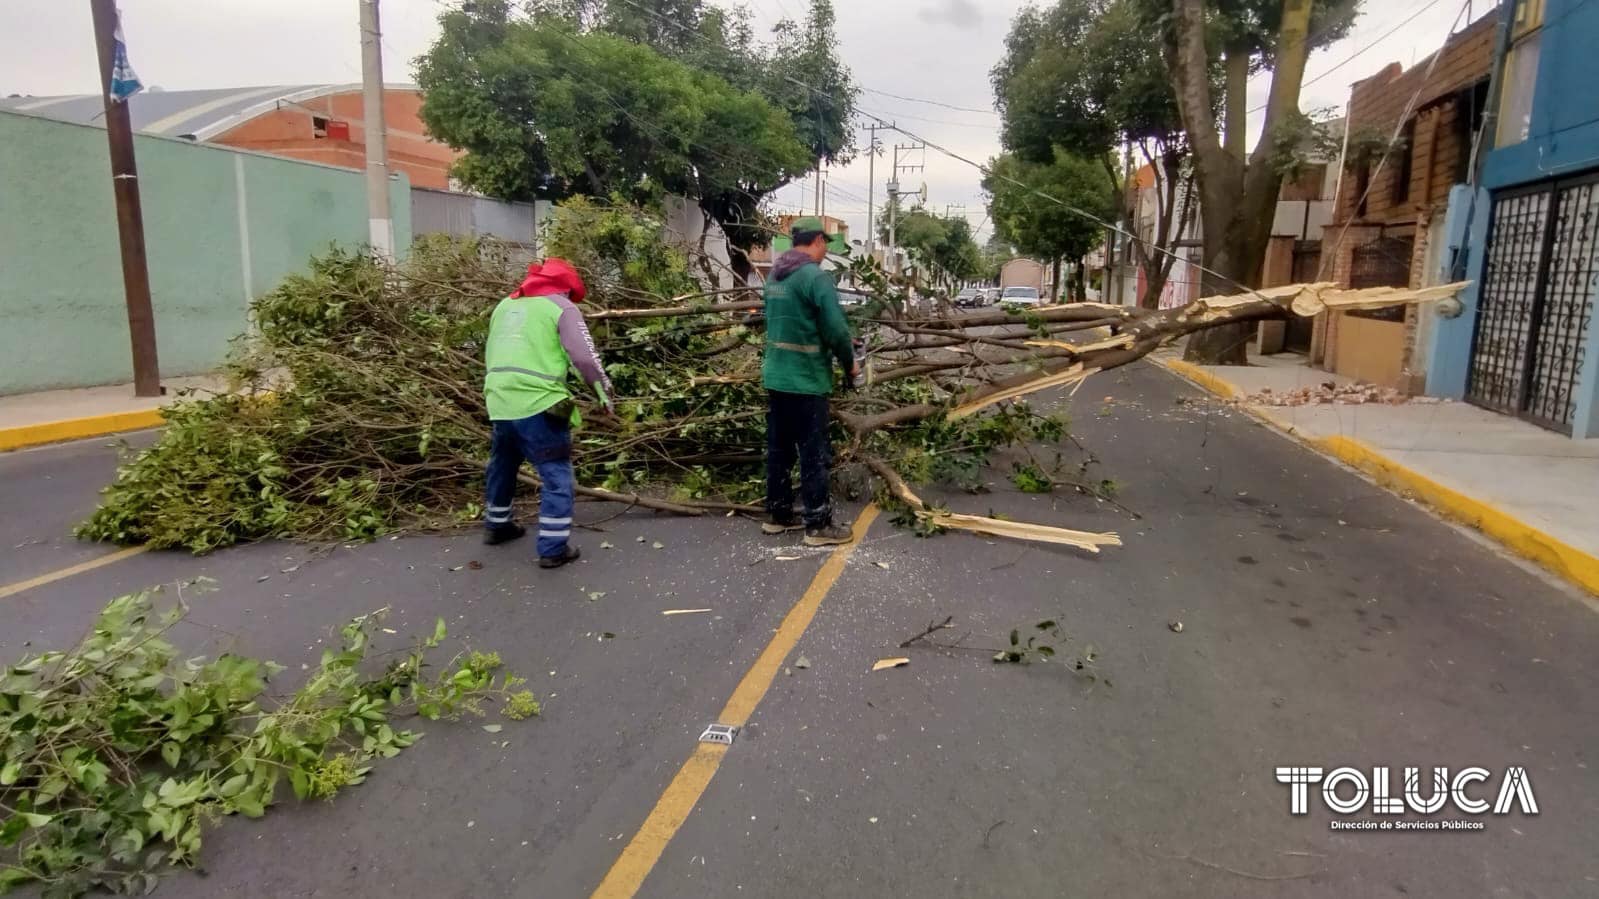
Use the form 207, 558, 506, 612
1154, 358, 1599, 595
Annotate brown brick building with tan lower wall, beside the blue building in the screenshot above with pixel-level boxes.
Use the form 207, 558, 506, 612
1311, 10, 1497, 394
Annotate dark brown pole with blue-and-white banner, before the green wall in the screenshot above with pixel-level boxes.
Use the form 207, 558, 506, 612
90, 0, 161, 397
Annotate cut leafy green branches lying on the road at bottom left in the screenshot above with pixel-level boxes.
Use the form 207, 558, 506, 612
0, 575, 539, 897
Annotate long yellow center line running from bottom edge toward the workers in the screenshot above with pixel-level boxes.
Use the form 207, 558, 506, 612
592, 504, 878, 899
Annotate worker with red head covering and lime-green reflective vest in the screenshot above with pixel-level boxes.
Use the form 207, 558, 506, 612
483, 256, 611, 568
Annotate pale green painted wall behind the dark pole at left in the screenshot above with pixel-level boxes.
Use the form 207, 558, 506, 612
0, 112, 411, 395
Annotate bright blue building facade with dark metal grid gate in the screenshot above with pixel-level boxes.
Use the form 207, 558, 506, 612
1428, 0, 1599, 438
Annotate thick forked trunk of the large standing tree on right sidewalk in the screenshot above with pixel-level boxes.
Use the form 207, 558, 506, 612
1169, 0, 1310, 365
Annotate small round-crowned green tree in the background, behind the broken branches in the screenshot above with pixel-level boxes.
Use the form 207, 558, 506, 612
983, 149, 1116, 299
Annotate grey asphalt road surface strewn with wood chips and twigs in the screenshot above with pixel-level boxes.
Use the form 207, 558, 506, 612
0, 365, 1599, 899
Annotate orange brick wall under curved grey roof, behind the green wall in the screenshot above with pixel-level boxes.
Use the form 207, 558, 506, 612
214, 90, 461, 190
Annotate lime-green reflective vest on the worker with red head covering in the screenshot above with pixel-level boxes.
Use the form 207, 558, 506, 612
483, 296, 577, 426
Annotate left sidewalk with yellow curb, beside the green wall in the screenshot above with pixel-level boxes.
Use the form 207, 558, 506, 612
0, 374, 225, 453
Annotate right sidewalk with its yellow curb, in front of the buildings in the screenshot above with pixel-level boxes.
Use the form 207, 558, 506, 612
1151, 350, 1599, 595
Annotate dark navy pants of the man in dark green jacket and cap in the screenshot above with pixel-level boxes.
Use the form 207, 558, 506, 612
766, 390, 833, 528
